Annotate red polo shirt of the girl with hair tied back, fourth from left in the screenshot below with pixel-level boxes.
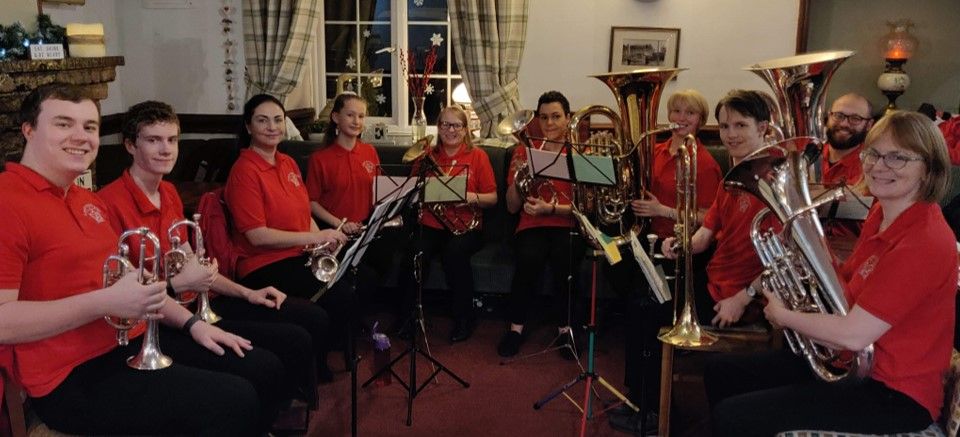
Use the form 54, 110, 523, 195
307, 141, 380, 223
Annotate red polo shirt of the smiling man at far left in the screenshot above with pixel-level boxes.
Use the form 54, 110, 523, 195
0, 163, 143, 397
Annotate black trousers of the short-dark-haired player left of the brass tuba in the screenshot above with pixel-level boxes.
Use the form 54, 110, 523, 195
507, 227, 584, 326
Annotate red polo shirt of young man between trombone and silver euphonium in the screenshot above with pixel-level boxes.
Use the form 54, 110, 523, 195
703, 189, 777, 302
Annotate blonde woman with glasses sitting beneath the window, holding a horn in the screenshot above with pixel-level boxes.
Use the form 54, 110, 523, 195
403, 106, 497, 342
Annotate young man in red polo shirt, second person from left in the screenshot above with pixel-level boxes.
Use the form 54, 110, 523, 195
97, 101, 332, 405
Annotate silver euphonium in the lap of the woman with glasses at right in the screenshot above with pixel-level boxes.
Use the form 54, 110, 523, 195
723, 146, 873, 382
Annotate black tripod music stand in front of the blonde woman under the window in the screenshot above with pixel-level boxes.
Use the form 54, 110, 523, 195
362, 155, 470, 426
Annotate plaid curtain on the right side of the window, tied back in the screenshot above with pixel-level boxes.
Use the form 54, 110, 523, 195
448, 0, 527, 138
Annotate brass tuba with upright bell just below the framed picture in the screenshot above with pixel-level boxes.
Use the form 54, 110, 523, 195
569, 68, 682, 245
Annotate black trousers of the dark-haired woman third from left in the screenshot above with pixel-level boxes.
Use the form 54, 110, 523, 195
239, 255, 357, 352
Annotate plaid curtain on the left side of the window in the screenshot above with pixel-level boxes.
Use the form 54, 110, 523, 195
243, 0, 318, 101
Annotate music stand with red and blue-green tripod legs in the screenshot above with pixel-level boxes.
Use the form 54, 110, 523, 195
533, 143, 639, 437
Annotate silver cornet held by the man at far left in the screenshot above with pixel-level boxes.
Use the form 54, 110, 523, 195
103, 227, 173, 370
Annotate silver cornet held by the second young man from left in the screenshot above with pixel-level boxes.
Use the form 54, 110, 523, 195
169, 214, 222, 325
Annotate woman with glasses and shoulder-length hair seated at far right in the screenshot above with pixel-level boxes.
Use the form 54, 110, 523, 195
704, 111, 957, 437
